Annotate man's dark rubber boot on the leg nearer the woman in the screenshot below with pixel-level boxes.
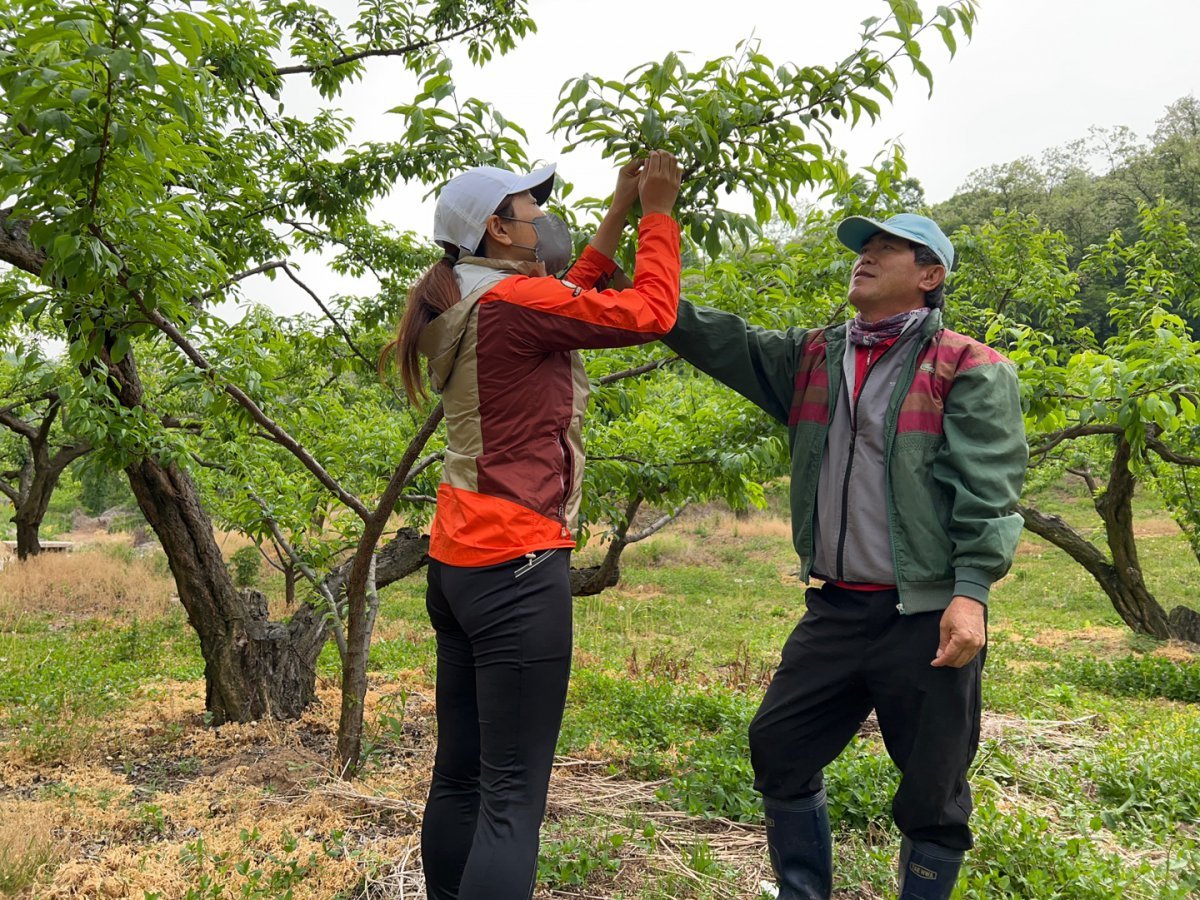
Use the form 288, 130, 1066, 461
762, 790, 833, 900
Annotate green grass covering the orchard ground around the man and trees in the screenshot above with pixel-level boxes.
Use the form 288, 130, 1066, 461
0, 490, 1200, 900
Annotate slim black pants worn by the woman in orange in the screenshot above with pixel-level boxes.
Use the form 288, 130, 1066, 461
421, 550, 571, 900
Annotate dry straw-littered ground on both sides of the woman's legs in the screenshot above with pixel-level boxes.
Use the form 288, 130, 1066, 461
0, 671, 782, 900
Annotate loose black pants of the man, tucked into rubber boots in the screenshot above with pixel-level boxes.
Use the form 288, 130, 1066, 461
750, 586, 985, 851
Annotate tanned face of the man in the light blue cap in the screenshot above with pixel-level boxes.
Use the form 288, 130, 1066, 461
847, 232, 944, 322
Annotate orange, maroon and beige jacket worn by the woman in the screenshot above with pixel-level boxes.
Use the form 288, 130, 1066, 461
419, 214, 679, 566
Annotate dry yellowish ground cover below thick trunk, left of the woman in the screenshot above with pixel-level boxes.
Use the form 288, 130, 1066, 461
0, 679, 433, 900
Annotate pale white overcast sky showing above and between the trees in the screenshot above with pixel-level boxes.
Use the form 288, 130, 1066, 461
253, 0, 1200, 312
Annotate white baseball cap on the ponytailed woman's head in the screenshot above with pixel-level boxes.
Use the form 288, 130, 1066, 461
433, 164, 554, 254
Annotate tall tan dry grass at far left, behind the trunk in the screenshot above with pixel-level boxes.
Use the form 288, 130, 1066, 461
0, 550, 175, 630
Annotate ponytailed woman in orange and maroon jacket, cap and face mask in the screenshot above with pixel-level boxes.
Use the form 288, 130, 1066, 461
388, 151, 680, 900
